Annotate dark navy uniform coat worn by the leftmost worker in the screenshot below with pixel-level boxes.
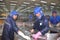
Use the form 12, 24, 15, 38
2, 16, 19, 40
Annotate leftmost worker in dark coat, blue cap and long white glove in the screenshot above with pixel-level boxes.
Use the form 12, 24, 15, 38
1, 10, 30, 40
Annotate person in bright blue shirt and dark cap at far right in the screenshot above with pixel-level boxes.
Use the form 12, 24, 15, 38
50, 10, 60, 27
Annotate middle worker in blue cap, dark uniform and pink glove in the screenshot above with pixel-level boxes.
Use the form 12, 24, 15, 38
31, 7, 49, 40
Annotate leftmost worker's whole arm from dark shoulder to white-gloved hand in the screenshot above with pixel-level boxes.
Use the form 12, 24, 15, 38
5, 19, 30, 40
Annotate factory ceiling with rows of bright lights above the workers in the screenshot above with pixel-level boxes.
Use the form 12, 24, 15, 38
0, 0, 60, 13
